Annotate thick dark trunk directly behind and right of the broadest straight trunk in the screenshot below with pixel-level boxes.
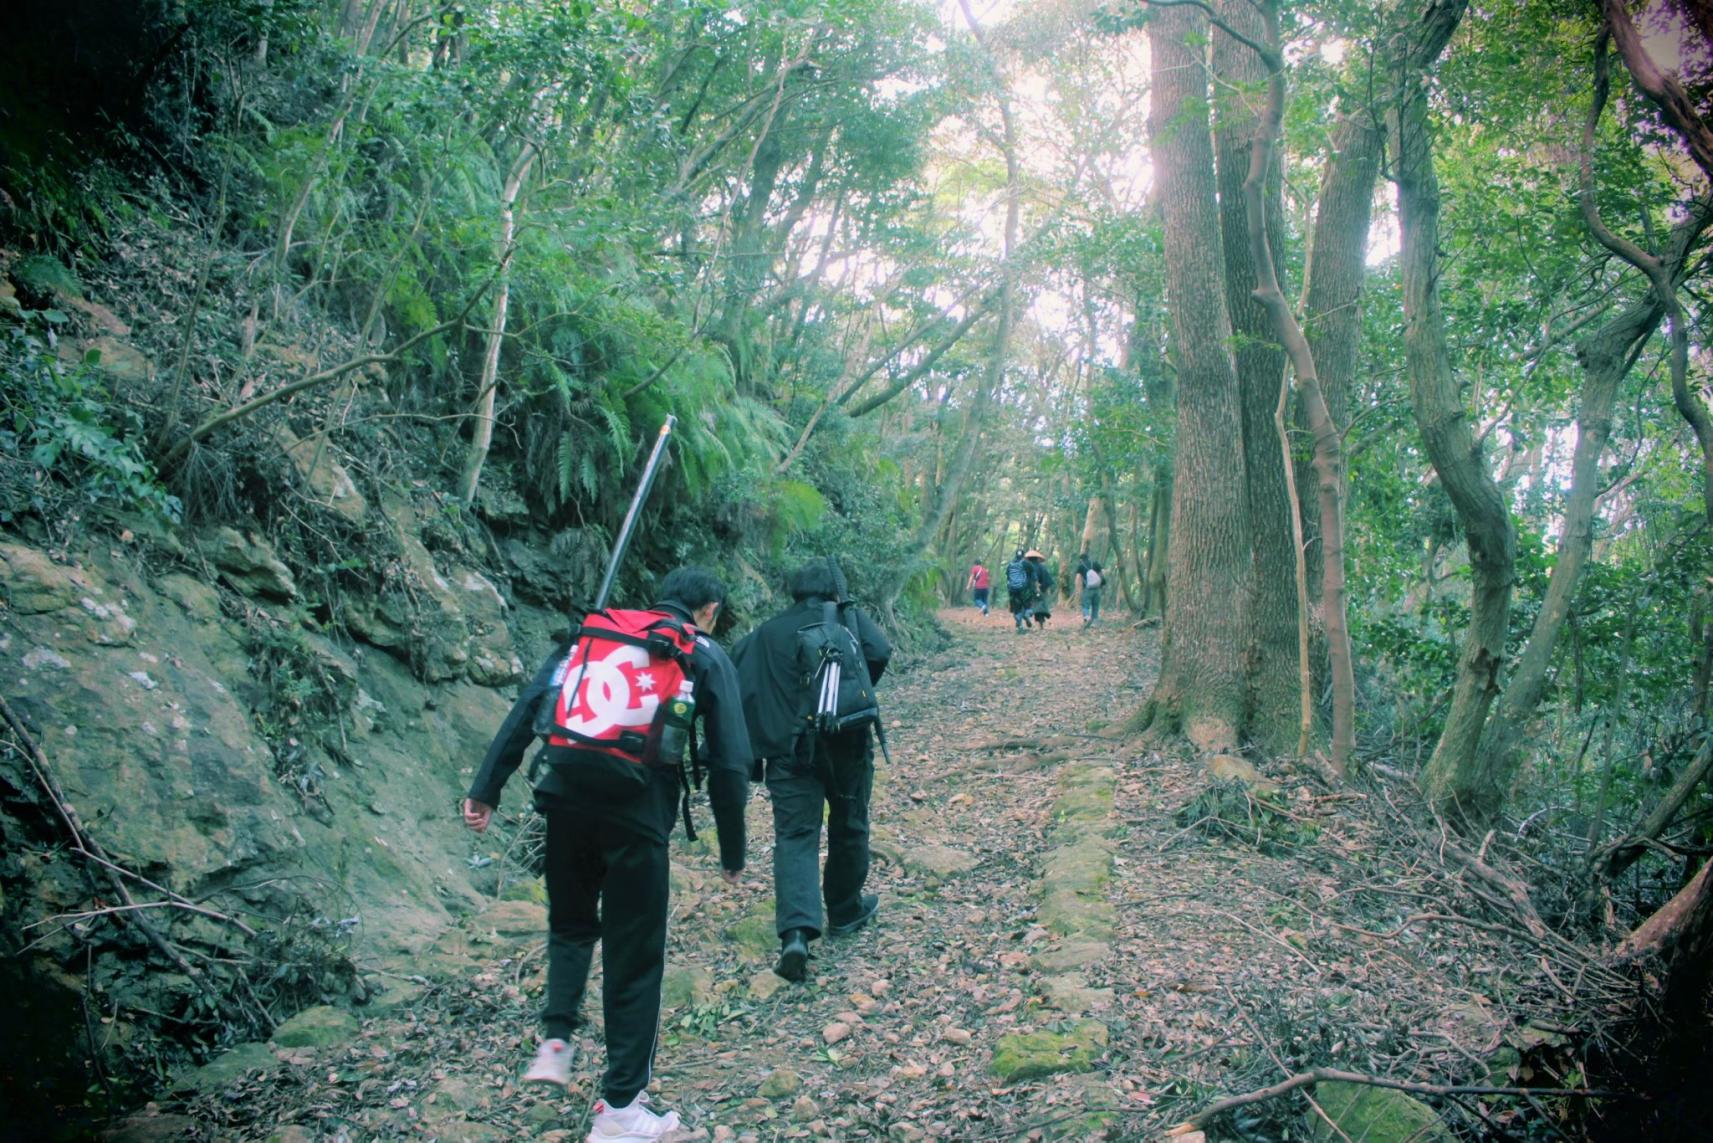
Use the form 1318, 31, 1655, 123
1213, 0, 1300, 754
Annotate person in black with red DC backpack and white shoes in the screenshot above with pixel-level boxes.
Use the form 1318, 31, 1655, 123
464, 567, 750, 1143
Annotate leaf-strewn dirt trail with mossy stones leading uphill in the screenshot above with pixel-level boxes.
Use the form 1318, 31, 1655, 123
154, 607, 1507, 1143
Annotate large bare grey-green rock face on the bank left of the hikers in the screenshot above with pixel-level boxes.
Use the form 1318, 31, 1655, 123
0, 530, 534, 1107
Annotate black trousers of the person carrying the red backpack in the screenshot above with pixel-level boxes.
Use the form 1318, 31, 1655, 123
541, 811, 670, 1107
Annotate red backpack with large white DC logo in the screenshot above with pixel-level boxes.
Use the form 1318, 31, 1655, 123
536, 608, 695, 766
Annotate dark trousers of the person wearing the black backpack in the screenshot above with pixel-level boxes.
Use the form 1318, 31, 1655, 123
767, 730, 874, 939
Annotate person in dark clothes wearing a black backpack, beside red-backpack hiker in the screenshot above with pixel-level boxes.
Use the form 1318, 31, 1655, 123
731, 560, 892, 982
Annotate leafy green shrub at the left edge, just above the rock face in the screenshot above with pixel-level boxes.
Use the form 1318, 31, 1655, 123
0, 308, 180, 523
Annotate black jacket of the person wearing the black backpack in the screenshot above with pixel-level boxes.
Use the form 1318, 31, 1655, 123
731, 595, 892, 759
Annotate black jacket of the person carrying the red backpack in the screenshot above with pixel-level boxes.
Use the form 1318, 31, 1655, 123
469, 603, 754, 869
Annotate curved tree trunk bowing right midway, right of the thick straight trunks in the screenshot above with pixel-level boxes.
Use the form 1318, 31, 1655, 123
1388, 0, 1516, 828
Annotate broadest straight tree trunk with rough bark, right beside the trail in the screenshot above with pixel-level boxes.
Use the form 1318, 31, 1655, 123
1139, 7, 1250, 751
